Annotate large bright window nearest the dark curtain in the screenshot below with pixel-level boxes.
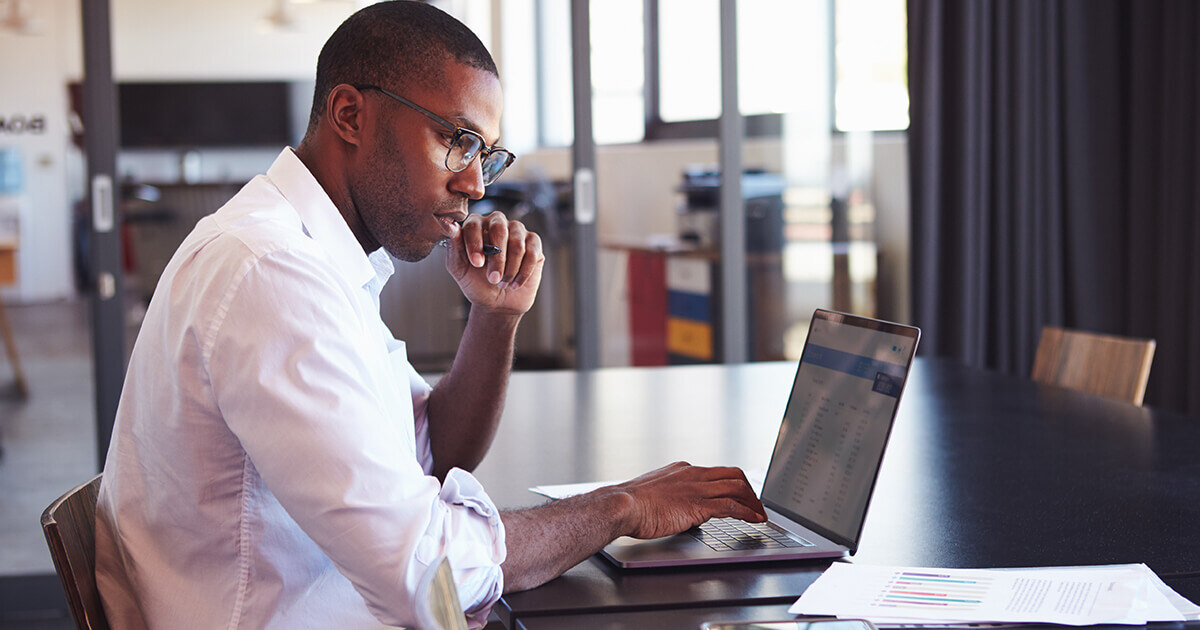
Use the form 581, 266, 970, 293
647, 0, 908, 137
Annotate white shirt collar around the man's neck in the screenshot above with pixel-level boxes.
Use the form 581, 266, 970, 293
266, 146, 379, 287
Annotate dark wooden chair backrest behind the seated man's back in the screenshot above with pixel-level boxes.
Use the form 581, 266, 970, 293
42, 475, 109, 630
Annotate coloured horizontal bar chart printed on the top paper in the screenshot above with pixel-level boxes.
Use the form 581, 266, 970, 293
871, 571, 992, 617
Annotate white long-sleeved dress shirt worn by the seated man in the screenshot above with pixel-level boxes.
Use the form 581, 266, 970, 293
96, 149, 505, 630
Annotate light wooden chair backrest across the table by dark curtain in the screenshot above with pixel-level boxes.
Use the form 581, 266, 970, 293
1032, 326, 1154, 406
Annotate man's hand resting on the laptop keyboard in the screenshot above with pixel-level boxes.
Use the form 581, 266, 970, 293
609, 462, 767, 539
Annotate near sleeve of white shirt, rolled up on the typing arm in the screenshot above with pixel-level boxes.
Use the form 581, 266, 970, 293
202, 250, 505, 625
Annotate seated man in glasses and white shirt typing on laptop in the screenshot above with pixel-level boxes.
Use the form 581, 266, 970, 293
96, 1, 766, 629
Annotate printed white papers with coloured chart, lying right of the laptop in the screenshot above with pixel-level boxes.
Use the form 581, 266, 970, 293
790, 563, 1200, 625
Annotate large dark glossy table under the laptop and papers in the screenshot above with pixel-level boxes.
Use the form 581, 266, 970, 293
476, 359, 1200, 630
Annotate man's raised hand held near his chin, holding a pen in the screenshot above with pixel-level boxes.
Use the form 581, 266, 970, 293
446, 212, 546, 316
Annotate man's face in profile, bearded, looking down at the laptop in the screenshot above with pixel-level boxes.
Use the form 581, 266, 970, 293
349, 61, 503, 262
